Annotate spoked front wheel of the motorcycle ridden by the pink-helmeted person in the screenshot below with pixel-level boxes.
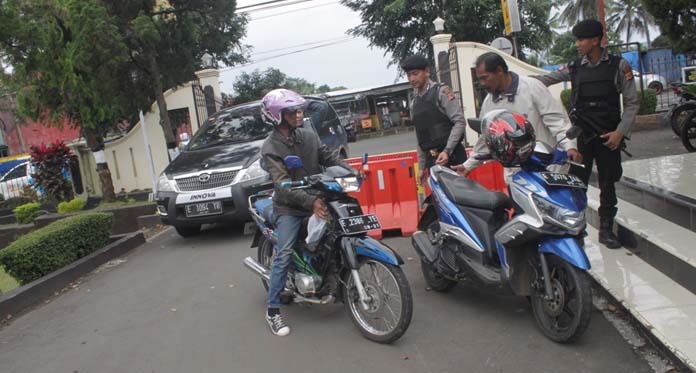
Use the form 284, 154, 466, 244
343, 259, 413, 344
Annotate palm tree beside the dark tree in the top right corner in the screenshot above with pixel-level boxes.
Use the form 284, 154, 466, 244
607, 0, 655, 48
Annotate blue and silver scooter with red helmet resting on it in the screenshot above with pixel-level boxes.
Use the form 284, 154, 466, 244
412, 123, 592, 342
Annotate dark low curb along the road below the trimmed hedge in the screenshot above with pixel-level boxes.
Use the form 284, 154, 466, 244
0, 231, 145, 321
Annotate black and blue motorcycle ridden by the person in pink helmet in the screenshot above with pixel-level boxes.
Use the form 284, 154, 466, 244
244, 156, 413, 343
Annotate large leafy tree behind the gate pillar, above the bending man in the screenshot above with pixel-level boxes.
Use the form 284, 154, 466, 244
341, 0, 552, 64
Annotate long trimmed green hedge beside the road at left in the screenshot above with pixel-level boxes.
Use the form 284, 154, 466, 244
0, 213, 113, 284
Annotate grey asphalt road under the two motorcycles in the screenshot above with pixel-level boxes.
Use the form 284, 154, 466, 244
0, 229, 651, 373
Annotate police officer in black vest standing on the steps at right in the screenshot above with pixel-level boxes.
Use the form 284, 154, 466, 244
535, 19, 638, 249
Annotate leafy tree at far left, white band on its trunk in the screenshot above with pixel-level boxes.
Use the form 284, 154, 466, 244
0, 0, 128, 200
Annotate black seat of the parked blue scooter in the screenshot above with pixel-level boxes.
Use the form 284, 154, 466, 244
440, 172, 512, 210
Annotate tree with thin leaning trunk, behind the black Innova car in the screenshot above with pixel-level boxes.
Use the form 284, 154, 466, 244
104, 0, 247, 149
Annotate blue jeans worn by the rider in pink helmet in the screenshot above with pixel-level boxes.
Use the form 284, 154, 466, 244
268, 215, 302, 308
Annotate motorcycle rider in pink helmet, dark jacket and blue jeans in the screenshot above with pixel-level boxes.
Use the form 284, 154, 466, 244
261, 89, 352, 336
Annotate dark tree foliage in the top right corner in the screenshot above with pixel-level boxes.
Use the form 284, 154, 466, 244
643, 0, 696, 52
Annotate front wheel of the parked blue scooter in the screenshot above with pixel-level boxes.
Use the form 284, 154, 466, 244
531, 255, 592, 343
